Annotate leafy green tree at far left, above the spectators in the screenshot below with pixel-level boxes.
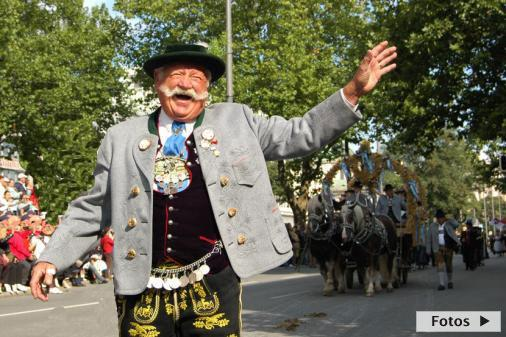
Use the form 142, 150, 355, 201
0, 0, 130, 221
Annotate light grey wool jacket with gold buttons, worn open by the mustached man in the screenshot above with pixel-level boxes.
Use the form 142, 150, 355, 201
39, 92, 361, 295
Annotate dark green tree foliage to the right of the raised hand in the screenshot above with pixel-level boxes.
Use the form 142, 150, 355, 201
369, 0, 506, 148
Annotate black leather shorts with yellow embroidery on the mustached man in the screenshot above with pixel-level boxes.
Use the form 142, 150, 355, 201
116, 267, 241, 337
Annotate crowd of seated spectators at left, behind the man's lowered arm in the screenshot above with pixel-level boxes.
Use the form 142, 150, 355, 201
0, 173, 114, 295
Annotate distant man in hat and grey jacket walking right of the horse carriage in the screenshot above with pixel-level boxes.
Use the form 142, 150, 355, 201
427, 209, 460, 290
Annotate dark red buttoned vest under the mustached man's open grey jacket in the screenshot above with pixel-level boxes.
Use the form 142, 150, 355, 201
153, 133, 230, 273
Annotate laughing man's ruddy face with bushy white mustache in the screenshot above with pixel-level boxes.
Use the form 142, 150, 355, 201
155, 63, 209, 122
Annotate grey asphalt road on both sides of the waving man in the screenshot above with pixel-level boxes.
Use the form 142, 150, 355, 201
0, 256, 506, 337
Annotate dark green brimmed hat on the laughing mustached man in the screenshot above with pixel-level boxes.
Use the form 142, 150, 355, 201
142, 44, 225, 82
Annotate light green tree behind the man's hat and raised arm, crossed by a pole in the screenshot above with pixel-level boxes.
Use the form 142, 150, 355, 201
115, 0, 368, 226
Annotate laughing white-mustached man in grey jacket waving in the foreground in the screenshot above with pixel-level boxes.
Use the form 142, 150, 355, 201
31, 41, 397, 336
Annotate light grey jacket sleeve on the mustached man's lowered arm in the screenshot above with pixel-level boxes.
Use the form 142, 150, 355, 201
38, 132, 112, 270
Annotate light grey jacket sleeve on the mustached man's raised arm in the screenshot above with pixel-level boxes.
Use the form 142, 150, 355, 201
243, 92, 362, 160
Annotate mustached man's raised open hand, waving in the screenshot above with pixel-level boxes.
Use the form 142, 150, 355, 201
343, 41, 397, 105
